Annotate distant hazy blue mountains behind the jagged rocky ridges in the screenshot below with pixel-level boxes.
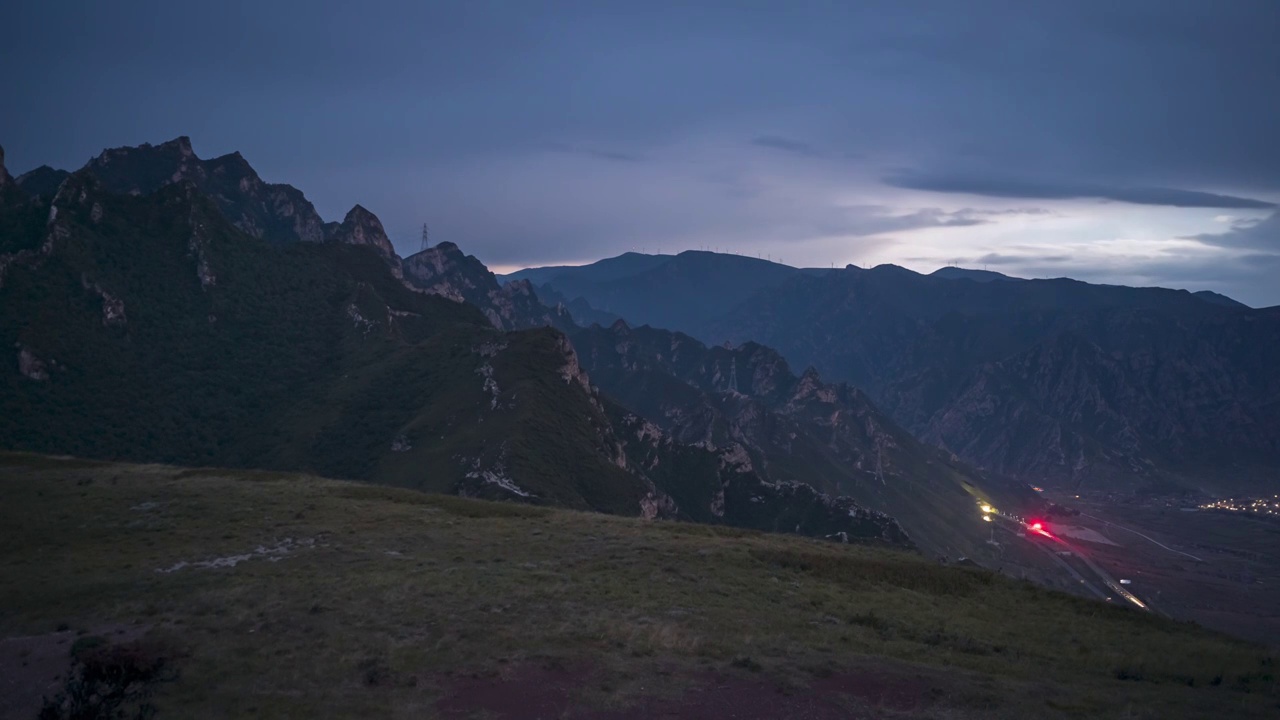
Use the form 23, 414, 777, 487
508, 245, 1280, 495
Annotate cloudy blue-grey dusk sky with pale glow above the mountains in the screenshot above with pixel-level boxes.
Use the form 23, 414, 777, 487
0, 0, 1280, 306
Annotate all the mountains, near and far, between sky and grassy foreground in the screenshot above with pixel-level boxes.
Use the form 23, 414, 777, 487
15, 131, 1280, 559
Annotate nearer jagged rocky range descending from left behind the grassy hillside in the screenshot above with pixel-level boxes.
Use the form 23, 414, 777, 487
0, 138, 977, 555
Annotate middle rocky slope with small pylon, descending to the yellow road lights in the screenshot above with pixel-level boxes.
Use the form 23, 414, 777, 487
570, 322, 1033, 556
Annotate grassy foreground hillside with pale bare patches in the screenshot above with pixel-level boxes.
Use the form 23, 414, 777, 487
0, 455, 1280, 719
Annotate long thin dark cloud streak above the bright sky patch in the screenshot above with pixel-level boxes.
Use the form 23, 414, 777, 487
884, 173, 1276, 210
